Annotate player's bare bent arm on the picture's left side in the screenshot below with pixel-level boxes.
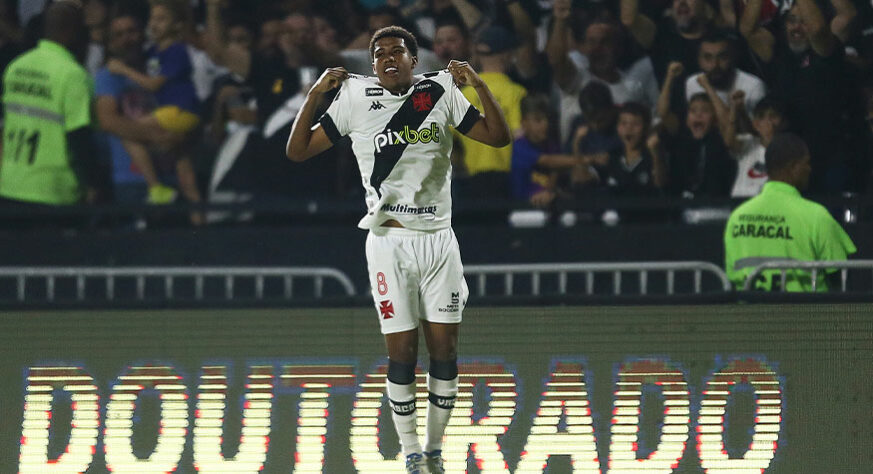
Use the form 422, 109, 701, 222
285, 67, 349, 161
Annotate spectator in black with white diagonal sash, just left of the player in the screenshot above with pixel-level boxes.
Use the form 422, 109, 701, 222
205, 0, 346, 198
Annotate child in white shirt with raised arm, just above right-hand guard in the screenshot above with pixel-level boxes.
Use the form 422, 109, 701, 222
710, 91, 787, 197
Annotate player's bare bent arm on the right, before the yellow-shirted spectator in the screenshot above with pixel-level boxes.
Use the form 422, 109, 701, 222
448, 60, 512, 148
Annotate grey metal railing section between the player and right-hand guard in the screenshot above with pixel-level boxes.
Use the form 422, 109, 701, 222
464, 262, 731, 296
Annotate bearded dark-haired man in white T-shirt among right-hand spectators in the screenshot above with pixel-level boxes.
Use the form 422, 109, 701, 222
685, 30, 766, 120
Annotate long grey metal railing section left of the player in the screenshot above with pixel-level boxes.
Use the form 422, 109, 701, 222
0, 267, 356, 302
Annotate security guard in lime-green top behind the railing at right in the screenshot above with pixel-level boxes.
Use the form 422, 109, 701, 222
724, 133, 856, 291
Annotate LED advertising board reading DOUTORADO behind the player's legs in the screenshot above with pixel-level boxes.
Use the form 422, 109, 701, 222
0, 305, 873, 474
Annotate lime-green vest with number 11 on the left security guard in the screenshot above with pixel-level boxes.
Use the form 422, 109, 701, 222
0, 40, 94, 204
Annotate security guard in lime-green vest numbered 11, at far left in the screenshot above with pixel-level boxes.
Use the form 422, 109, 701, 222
0, 0, 99, 205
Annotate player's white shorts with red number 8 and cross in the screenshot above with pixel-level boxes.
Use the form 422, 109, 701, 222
366, 227, 469, 334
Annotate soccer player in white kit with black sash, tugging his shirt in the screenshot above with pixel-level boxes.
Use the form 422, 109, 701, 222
286, 26, 510, 474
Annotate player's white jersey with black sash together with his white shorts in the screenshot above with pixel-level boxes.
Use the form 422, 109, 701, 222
321, 72, 479, 334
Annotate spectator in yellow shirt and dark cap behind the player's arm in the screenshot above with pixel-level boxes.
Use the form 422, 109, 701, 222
458, 26, 527, 198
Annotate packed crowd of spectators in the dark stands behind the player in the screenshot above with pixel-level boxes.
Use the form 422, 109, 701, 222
0, 0, 873, 224
